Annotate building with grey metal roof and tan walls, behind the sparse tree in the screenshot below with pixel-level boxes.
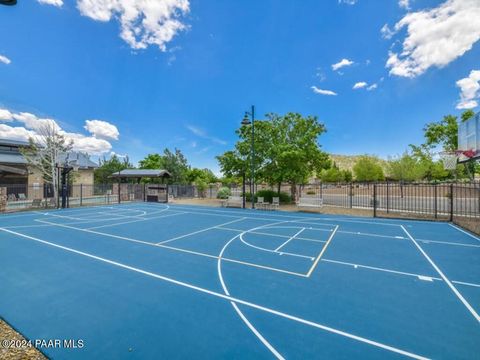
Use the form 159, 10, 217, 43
0, 139, 98, 199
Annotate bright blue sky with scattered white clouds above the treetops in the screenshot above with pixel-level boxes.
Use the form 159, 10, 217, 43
0, 0, 480, 171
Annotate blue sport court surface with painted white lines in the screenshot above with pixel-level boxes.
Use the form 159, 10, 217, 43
0, 203, 480, 359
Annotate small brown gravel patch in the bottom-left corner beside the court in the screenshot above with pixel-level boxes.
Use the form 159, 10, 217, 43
0, 319, 48, 360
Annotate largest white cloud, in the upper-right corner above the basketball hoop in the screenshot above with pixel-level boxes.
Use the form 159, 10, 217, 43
386, 0, 480, 78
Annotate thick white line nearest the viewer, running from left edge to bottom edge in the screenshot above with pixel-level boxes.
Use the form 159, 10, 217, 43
0, 228, 428, 360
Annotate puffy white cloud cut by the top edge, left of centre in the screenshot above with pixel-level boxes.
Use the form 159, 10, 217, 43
77, 0, 190, 51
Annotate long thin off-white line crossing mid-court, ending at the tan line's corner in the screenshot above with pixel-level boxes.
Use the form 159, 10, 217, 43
36, 220, 306, 277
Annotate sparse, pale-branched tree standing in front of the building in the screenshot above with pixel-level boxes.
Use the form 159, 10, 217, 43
21, 120, 73, 198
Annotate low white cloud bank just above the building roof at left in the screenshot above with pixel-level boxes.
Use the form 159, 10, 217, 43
0, 109, 118, 155
